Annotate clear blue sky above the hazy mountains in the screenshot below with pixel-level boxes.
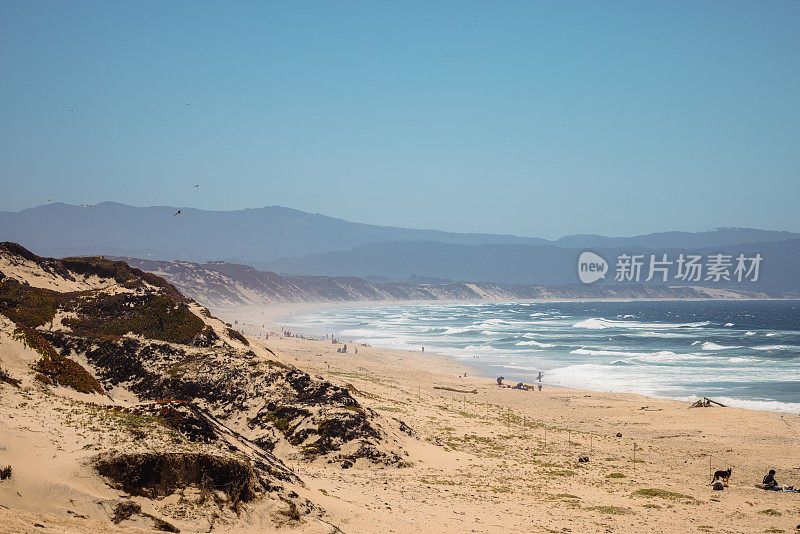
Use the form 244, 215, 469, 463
0, 0, 800, 237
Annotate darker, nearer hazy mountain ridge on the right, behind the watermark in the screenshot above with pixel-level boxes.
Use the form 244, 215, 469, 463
265, 239, 800, 289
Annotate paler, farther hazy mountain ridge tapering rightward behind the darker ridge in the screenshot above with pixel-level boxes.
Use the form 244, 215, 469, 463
0, 202, 546, 264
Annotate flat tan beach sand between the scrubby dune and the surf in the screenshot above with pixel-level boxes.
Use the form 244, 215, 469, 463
216, 306, 800, 532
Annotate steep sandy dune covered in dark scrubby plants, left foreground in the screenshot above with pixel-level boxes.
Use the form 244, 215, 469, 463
0, 243, 408, 531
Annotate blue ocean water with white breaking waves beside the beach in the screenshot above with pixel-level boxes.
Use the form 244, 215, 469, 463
284, 301, 800, 413
